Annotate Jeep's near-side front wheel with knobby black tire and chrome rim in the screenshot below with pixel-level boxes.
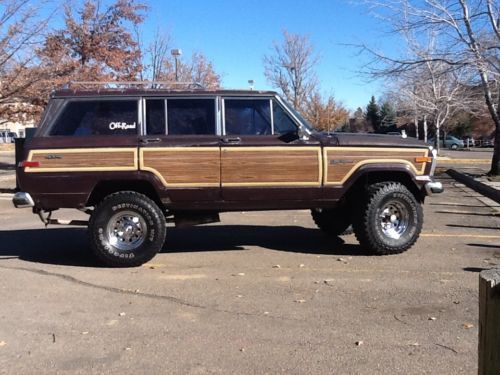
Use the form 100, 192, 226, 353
353, 182, 423, 255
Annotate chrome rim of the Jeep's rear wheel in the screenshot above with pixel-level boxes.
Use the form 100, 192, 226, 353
107, 211, 148, 251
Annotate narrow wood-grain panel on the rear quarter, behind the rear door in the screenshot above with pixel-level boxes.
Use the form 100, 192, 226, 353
26, 148, 137, 173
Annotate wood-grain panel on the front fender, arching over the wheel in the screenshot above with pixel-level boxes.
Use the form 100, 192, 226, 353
323, 147, 429, 185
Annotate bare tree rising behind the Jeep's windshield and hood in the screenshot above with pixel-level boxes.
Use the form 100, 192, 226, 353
264, 30, 319, 110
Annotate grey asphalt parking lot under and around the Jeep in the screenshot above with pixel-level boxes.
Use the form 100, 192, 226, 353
0, 148, 500, 374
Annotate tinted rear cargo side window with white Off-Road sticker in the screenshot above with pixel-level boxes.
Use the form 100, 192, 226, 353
50, 100, 137, 136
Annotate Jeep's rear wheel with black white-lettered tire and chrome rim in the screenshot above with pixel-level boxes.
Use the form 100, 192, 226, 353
89, 191, 167, 267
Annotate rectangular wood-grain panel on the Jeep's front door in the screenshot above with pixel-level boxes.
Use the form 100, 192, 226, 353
221, 147, 322, 186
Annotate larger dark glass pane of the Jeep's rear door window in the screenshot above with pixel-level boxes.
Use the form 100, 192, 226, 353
167, 99, 215, 135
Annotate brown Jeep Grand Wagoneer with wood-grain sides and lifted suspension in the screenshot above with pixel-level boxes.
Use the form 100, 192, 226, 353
13, 85, 443, 266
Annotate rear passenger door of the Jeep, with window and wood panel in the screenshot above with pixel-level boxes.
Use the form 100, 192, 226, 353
139, 96, 220, 202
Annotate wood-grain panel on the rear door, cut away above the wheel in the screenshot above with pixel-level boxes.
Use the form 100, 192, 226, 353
140, 147, 220, 187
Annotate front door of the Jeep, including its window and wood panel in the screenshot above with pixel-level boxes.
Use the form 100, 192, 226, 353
221, 96, 322, 206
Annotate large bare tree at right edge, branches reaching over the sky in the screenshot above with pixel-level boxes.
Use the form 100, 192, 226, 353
356, 0, 500, 175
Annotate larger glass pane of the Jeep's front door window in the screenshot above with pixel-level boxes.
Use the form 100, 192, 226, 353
224, 99, 272, 135
